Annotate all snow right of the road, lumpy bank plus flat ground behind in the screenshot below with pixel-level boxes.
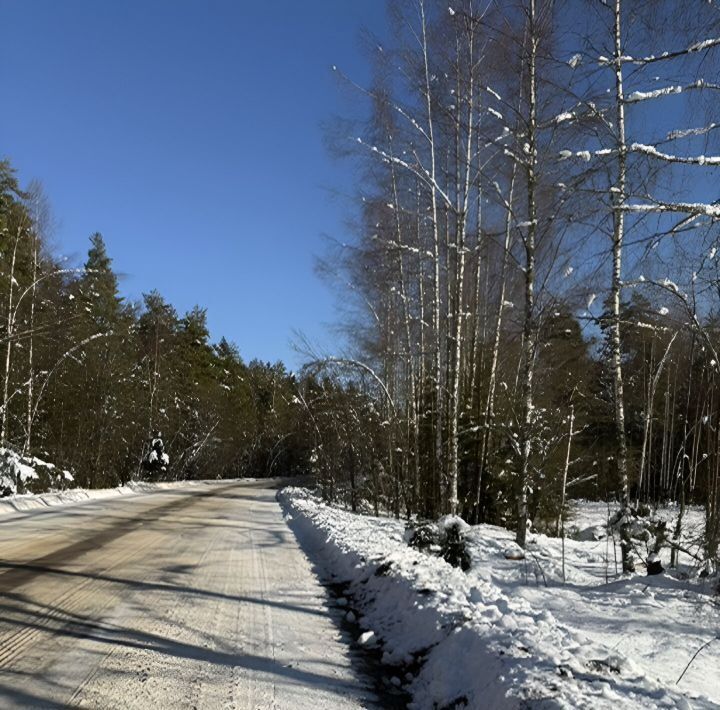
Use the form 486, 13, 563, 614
279, 488, 720, 710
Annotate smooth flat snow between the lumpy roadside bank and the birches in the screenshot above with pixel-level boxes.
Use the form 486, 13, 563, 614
469, 502, 720, 706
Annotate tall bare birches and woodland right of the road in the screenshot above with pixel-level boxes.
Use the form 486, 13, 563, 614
315, 0, 720, 568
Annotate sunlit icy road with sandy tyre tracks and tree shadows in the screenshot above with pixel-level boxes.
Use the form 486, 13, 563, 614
0, 482, 373, 710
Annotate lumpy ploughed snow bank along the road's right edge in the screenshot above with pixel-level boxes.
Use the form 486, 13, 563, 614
278, 488, 717, 710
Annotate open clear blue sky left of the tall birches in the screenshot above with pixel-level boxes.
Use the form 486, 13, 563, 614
0, 0, 385, 366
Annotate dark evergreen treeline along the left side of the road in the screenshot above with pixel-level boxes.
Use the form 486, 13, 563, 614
0, 161, 329, 487
